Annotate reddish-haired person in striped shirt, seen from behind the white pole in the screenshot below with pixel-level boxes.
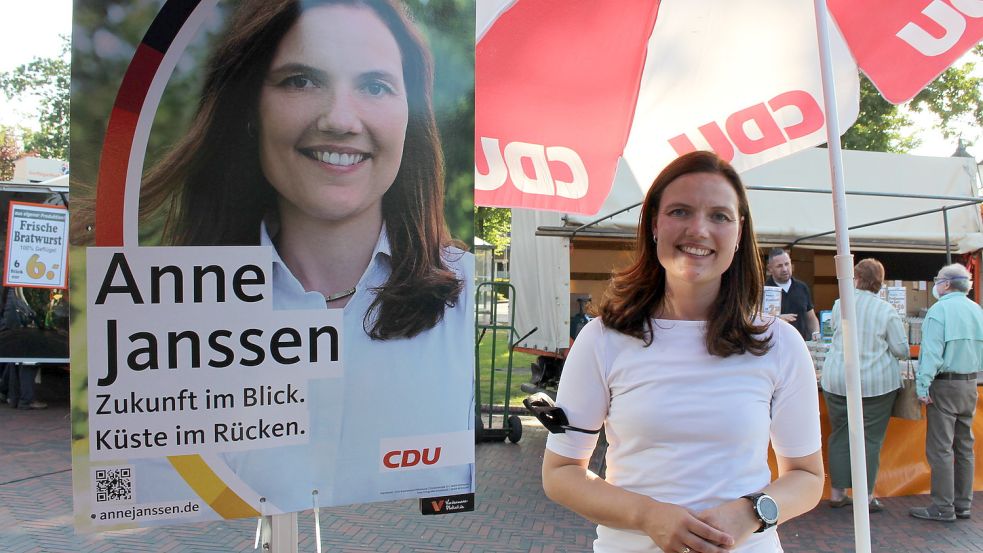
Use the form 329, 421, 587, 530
821, 259, 908, 512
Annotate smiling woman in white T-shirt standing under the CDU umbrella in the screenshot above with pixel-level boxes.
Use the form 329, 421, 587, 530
543, 152, 823, 553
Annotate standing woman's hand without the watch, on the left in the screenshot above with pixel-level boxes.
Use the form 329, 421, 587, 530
642, 499, 747, 553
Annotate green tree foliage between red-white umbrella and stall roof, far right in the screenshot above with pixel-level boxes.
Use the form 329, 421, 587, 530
842, 45, 983, 153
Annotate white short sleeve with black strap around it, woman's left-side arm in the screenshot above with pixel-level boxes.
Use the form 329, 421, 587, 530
546, 318, 611, 459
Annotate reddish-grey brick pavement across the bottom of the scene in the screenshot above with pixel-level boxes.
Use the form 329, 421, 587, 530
0, 394, 983, 553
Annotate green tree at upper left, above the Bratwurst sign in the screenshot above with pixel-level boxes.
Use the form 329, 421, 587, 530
0, 36, 71, 160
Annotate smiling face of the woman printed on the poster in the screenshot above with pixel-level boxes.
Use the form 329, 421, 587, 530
259, 6, 408, 222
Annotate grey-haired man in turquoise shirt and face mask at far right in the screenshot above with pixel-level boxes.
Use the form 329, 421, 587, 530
909, 263, 983, 522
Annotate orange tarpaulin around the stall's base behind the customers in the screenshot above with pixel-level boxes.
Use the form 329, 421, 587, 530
768, 391, 983, 498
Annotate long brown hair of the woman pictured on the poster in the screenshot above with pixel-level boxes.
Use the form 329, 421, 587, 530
140, 0, 463, 340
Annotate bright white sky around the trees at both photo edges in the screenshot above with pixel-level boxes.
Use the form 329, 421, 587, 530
0, 0, 983, 160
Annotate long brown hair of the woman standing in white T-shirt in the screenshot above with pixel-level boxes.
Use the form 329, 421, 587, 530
600, 151, 770, 357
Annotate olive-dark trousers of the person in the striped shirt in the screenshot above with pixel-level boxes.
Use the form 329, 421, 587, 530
823, 390, 898, 495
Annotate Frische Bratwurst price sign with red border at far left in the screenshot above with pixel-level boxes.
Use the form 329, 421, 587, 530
3, 202, 68, 288
